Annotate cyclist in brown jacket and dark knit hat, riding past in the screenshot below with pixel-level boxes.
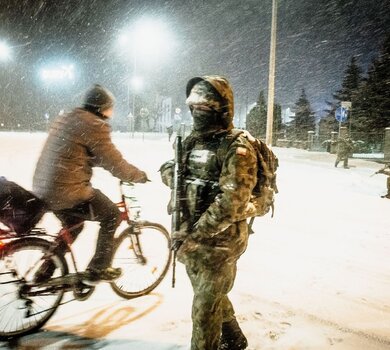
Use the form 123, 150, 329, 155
33, 85, 148, 282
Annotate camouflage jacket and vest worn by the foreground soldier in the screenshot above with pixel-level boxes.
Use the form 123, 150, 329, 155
162, 131, 257, 264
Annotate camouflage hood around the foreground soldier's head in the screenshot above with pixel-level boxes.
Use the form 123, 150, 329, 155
186, 75, 234, 129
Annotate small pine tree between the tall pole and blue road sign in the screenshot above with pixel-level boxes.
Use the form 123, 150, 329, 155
289, 89, 315, 141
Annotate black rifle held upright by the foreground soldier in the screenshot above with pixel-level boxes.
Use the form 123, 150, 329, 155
171, 126, 183, 288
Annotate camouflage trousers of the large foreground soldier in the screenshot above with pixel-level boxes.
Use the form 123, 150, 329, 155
186, 261, 237, 350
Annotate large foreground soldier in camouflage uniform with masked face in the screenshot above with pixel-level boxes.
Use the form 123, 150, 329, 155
161, 76, 257, 350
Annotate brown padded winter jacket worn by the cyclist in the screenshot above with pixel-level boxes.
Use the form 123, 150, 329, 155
33, 108, 144, 210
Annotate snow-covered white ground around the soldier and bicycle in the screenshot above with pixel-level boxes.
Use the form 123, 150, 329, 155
0, 133, 390, 350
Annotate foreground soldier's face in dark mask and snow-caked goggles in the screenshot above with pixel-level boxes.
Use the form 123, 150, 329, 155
186, 80, 223, 134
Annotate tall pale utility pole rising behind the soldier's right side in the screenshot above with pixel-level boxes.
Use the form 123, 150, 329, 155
265, 0, 277, 146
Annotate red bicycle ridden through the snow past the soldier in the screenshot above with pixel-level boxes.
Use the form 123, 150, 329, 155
0, 182, 171, 340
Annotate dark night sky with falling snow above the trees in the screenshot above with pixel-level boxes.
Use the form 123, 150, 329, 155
0, 0, 390, 129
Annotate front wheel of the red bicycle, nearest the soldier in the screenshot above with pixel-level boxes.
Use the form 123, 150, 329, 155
111, 221, 172, 299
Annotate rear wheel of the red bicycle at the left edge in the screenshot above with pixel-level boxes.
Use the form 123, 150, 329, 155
0, 237, 68, 339
